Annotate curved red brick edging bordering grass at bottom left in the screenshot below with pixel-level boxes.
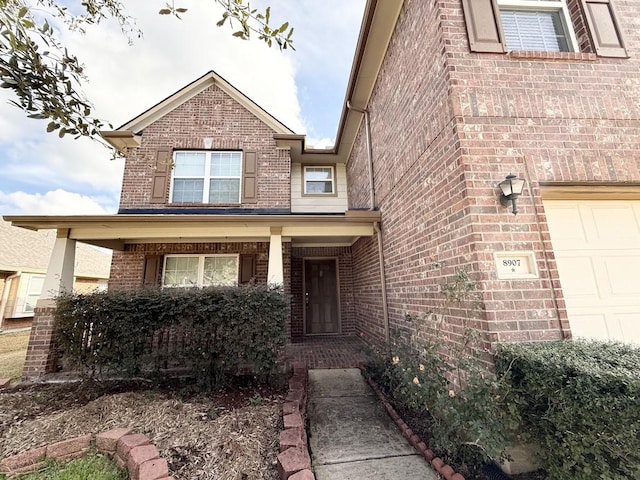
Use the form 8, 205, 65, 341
0, 428, 173, 480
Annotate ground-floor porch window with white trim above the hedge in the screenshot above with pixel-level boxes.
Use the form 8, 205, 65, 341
162, 255, 239, 287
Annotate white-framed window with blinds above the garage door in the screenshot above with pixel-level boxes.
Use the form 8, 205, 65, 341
498, 0, 577, 52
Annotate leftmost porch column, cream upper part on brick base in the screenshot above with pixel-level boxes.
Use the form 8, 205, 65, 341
22, 228, 76, 381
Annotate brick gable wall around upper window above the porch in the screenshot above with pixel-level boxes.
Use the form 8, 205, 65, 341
120, 86, 291, 208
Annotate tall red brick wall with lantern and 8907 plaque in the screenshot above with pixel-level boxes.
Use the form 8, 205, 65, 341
347, 0, 640, 352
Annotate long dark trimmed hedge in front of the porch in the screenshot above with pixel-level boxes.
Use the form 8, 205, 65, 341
55, 285, 288, 387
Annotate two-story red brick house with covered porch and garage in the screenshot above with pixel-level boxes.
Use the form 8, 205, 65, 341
8, 0, 640, 375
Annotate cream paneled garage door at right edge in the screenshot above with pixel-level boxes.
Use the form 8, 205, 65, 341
544, 200, 640, 343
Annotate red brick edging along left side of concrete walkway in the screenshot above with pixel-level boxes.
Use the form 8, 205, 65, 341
278, 362, 316, 480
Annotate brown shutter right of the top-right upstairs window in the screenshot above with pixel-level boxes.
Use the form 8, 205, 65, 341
582, 0, 629, 58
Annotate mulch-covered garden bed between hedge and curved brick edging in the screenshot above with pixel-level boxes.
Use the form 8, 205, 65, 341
0, 383, 284, 480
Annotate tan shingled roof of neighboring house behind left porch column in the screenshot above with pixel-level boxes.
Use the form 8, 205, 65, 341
0, 219, 111, 278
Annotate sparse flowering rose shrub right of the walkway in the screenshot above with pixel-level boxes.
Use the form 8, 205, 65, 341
368, 318, 519, 470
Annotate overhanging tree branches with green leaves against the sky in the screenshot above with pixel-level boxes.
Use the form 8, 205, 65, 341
0, 0, 293, 141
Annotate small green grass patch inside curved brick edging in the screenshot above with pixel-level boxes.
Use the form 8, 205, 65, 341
0, 453, 127, 480
